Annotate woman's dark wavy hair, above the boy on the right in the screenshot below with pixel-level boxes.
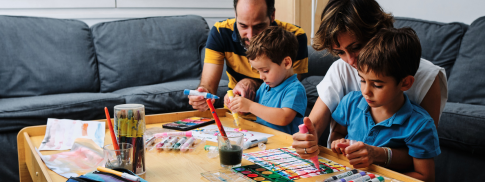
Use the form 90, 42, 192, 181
312, 0, 394, 56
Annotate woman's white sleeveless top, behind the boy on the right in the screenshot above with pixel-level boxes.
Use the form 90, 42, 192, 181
317, 58, 448, 148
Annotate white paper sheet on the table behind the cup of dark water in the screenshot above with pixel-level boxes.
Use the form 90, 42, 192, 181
192, 125, 273, 142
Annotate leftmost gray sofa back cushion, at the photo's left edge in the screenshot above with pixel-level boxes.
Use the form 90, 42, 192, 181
0, 16, 99, 98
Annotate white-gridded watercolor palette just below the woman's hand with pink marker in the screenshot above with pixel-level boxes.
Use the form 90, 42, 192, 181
243, 148, 350, 180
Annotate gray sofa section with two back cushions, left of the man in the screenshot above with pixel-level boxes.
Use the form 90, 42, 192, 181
0, 15, 228, 181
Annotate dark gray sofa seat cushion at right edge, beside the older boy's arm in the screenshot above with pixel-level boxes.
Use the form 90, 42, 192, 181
438, 102, 485, 155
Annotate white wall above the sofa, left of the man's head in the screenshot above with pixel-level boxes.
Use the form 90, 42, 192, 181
0, 0, 234, 27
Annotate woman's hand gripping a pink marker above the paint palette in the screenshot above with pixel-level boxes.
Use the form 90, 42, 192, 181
292, 117, 320, 159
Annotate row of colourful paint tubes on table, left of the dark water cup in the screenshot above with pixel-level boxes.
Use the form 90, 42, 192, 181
153, 131, 205, 152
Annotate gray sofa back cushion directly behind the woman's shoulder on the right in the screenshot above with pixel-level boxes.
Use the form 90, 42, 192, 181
394, 17, 468, 78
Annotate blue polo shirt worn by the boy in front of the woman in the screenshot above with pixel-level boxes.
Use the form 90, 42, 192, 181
332, 91, 441, 158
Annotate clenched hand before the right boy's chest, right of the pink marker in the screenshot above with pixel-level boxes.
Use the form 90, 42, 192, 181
342, 142, 376, 168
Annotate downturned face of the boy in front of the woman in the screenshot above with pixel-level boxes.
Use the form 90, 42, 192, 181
359, 69, 407, 107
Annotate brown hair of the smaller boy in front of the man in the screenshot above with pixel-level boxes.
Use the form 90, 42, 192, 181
246, 26, 298, 65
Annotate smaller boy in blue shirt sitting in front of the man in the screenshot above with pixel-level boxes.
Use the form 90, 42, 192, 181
227, 26, 307, 135
